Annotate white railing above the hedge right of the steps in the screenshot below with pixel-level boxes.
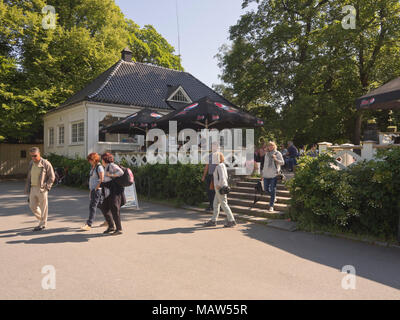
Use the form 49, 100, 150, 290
318, 141, 400, 170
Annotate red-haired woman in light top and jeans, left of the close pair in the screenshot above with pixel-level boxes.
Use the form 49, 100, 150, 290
81, 152, 104, 231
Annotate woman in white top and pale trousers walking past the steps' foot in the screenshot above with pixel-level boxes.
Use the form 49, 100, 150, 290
205, 152, 236, 228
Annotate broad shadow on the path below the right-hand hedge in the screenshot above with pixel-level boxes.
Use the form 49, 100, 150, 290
242, 224, 400, 297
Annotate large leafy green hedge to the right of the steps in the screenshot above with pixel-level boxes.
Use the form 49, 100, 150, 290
287, 148, 400, 240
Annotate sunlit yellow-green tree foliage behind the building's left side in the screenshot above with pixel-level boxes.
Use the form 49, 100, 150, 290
0, 0, 183, 142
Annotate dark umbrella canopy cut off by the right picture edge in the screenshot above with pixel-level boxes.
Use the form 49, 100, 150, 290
356, 77, 400, 110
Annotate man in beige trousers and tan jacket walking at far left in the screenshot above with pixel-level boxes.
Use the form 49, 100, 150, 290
25, 147, 55, 231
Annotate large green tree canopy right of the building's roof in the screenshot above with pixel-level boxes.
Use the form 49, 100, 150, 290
218, 0, 400, 144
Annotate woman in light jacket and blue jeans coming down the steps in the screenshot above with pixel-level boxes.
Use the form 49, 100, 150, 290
261, 141, 285, 212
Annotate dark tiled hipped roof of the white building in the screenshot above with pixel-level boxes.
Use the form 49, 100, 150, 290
56, 60, 232, 110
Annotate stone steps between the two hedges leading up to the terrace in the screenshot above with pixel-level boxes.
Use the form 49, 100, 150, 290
228, 177, 290, 222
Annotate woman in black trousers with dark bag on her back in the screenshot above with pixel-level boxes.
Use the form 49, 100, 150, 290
101, 152, 126, 235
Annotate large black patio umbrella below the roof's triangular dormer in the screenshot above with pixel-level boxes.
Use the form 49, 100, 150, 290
156, 97, 264, 131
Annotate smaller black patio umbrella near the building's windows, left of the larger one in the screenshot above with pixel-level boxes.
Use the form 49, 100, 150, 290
101, 108, 163, 135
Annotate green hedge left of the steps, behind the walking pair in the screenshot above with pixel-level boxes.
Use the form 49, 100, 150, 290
46, 154, 206, 205
